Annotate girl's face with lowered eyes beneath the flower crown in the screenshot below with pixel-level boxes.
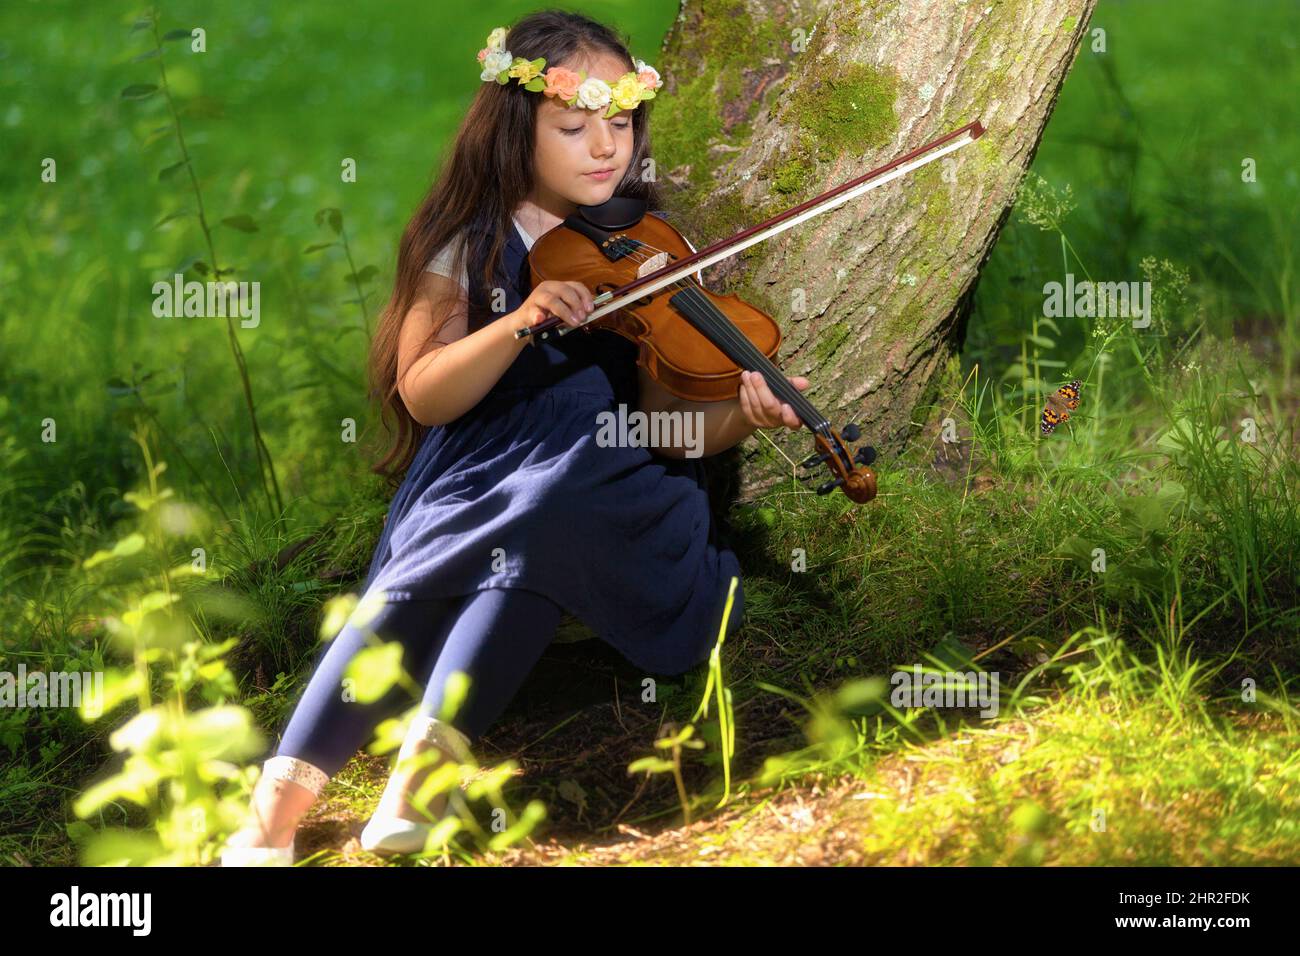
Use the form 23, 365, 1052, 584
534, 53, 641, 206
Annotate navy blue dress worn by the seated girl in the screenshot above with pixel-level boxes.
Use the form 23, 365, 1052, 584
363, 210, 744, 674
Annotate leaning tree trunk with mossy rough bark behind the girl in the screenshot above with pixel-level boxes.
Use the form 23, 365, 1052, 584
653, 0, 1096, 497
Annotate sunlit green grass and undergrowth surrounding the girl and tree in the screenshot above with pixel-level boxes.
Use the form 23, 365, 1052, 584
0, 0, 1300, 865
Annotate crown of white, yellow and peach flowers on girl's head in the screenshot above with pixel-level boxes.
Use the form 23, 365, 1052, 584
478, 26, 663, 118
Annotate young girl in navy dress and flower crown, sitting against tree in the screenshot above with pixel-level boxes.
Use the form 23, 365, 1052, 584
222, 10, 807, 866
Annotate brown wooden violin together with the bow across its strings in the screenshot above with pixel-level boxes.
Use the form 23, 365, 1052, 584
516, 121, 984, 505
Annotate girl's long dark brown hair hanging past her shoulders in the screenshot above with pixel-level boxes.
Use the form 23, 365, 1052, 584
369, 10, 663, 485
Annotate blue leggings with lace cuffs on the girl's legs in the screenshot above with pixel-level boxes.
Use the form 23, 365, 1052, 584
276, 588, 562, 777
